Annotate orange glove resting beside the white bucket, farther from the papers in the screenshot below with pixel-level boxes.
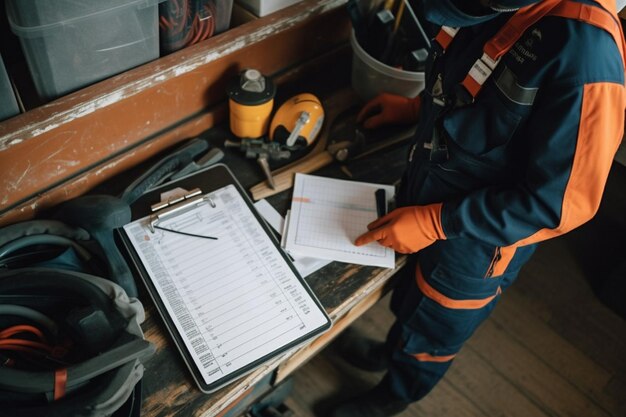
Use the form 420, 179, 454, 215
356, 93, 421, 129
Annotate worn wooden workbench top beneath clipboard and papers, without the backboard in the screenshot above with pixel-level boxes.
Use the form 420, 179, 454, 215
131, 123, 406, 417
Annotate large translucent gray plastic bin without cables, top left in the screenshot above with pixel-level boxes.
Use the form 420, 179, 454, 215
6, 0, 162, 99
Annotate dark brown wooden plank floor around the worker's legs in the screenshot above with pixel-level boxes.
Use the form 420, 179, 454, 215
286, 165, 626, 417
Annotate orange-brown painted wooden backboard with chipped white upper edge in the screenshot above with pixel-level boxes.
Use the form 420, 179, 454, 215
0, 0, 349, 223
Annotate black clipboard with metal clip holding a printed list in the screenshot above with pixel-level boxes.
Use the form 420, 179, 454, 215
118, 164, 331, 393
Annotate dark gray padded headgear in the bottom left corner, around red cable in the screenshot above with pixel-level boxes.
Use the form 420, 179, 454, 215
0, 268, 155, 417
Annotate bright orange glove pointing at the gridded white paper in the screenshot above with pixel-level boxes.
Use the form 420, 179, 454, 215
354, 203, 446, 253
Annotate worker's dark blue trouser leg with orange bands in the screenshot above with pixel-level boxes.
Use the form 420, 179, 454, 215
385, 256, 513, 402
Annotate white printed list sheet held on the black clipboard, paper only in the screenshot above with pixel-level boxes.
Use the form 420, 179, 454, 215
124, 185, 327, 384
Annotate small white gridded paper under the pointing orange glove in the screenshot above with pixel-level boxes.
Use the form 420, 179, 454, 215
285, 174, 395, 268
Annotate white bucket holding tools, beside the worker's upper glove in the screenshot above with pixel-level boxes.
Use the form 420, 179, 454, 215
350, 30, 424, 101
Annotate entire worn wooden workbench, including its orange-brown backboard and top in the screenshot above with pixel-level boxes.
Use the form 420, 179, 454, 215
0, 0, 412, 417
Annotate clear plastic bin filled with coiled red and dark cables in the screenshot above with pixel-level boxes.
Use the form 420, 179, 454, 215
159, 0, 233, 55
